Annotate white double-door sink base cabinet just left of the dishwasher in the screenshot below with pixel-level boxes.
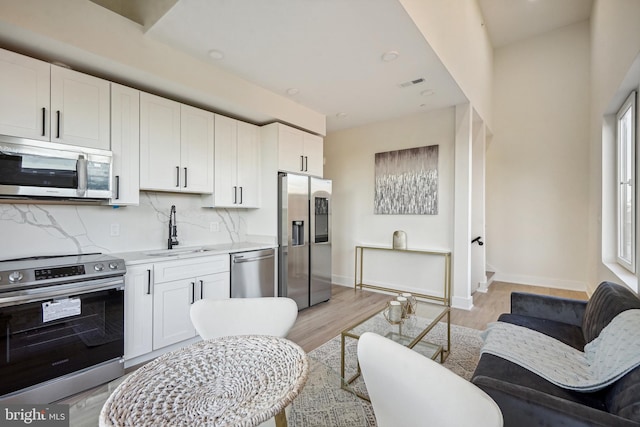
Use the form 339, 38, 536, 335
153, 255, 230, 350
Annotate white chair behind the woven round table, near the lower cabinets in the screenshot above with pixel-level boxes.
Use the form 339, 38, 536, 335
190, 297, 298, 339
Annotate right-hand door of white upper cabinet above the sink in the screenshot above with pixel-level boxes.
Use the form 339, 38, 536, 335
180, 105, 214, 193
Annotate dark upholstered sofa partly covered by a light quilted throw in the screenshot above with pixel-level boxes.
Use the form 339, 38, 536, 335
471, 282, 640, 427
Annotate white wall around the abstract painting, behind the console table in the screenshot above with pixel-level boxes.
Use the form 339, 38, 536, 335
324, 108, 455, 300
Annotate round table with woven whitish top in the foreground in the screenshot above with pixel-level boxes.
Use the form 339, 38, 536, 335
100, 335, 309, 427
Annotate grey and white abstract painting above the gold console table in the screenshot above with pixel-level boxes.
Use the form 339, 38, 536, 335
374, 145, 438, 215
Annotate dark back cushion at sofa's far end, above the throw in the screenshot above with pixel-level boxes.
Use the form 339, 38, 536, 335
584, 282, 640, 343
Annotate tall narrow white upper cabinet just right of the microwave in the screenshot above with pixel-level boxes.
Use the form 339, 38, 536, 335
109, 83, 140, 205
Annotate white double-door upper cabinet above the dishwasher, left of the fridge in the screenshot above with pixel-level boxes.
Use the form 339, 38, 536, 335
203, 114, 260, 208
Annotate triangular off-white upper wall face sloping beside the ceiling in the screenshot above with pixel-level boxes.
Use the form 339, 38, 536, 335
399, 0, 493, 128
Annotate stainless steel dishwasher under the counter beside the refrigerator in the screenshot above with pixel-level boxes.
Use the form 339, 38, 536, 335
231, 249, 275, 298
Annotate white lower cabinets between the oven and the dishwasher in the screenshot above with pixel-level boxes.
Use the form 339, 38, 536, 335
125, 254, 231, 360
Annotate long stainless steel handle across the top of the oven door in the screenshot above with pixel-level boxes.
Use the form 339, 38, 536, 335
0, 277, 124, 307
